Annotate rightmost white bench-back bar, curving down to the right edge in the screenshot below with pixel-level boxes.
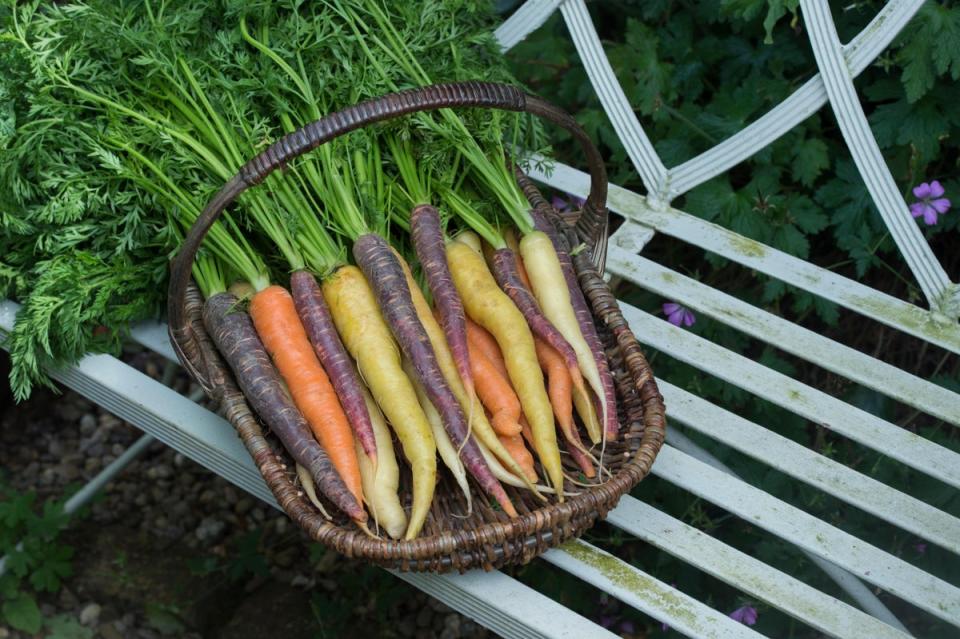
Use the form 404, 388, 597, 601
800, 0, 957, 312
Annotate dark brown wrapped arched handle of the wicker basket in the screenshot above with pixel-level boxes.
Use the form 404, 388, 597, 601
167, 82, 607, 380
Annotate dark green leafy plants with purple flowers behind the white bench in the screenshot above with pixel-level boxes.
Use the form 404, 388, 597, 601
508, 0, 960, 637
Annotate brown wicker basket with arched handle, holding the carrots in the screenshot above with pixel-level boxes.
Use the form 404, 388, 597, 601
168, 82, 665, 572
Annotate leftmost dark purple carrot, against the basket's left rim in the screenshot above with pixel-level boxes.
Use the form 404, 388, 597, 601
203, 293, 367, 524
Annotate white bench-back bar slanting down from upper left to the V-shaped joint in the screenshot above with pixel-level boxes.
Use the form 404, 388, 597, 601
560, 0, 667, 198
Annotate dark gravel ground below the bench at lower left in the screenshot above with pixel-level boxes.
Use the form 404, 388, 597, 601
0, 357, 495, 639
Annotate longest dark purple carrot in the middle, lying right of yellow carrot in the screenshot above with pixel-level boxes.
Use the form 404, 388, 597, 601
353, 233, 517, 517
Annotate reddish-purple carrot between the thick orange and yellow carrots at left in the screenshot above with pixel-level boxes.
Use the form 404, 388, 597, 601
290, 271, 377, 465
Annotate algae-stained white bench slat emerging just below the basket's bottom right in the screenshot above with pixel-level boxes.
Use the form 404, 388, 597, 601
542, 539, 762, 638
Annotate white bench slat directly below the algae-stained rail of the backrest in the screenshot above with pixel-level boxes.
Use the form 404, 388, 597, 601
607, 238, 960, 426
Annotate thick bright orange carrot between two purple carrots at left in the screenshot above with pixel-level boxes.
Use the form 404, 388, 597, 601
250, 285, 363, 504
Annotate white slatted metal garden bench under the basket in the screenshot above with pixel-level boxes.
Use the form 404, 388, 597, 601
0, 0, 960, 639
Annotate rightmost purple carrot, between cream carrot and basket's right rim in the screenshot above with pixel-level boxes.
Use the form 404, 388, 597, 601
524, 208, 620, 439
